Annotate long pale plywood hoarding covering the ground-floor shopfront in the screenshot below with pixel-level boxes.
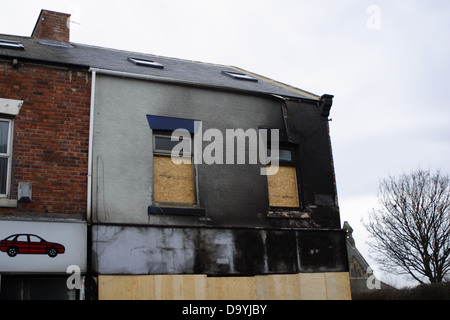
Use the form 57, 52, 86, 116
98, 272, 351, 300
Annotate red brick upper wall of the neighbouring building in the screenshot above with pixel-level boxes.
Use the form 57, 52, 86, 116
0, 62, 91, 218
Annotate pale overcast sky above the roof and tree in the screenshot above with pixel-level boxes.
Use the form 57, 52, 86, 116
0, 0, 450, 284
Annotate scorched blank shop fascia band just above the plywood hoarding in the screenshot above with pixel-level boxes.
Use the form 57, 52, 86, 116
93, 225, 348, 276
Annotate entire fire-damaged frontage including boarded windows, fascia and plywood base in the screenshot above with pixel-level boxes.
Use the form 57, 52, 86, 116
92, 73, 349, 299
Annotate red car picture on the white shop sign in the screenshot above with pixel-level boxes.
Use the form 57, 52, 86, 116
0, 234, 66, 258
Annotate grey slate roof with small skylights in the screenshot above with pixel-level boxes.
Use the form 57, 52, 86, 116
0, 34, 320, 101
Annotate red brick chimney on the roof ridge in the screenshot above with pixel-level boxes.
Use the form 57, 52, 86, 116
31, 10, 70, 45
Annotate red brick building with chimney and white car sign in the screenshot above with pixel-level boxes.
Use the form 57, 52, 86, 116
0, 11, 91, 299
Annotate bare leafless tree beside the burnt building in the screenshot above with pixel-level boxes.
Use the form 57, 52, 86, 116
363, 169, 450, 283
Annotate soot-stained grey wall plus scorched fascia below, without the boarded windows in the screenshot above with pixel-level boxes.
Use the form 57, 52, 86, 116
92, 75, 348, 276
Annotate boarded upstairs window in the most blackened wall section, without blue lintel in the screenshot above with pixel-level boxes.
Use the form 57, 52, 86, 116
267, 149, 300, 208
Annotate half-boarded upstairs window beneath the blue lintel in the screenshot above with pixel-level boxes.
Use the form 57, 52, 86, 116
153, 133, 196, 206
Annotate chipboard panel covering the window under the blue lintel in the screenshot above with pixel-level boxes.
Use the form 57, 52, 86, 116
153, 156, 195, 204
